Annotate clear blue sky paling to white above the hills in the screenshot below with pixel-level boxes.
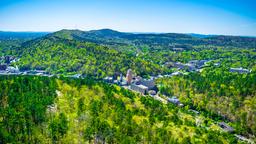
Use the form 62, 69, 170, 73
0, 0, 256, 36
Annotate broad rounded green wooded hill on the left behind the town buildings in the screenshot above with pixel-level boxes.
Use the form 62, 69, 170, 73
15, 31, 166, 77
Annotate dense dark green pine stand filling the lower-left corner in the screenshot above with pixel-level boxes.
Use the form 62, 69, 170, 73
0, 76, 56, 143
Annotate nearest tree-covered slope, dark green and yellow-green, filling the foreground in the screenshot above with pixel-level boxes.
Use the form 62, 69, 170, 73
0, 76, 237, 143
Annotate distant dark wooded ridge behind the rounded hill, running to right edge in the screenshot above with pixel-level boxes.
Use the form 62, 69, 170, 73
47, 29, 256, 48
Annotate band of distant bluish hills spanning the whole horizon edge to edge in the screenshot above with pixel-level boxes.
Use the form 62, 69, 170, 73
0, 29, 256, 50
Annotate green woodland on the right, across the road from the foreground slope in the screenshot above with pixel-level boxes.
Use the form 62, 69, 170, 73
159, 68, 256, 134
